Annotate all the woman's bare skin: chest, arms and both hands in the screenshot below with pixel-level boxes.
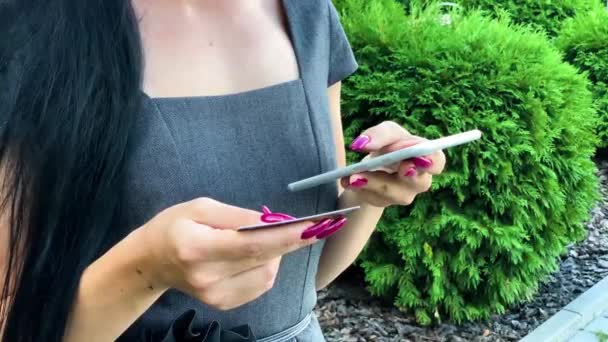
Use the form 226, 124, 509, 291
0, 0, 445, 342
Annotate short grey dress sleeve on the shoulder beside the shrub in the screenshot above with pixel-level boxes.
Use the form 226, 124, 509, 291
326, 0, 359, 87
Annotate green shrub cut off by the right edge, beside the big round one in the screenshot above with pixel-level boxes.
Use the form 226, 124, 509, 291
555, 8, 608, 147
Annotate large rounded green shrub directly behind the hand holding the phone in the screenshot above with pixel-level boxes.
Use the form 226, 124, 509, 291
337, 0, 598, 324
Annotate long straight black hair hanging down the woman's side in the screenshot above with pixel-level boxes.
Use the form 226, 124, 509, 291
0, 0, 143, 342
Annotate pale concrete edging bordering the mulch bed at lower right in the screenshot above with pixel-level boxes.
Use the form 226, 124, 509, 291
520, 277, 608, 342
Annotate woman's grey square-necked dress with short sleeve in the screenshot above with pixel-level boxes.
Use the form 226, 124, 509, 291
121, 0, 357, 341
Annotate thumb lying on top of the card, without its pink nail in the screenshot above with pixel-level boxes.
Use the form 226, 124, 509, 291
177, 198, 262, 230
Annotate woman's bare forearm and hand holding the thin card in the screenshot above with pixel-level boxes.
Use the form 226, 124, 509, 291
0, 184, 316, 342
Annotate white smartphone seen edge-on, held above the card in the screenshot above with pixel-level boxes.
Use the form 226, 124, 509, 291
287, 130, 482, 191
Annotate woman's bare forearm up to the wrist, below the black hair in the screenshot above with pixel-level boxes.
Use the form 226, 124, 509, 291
64, 229, 166, 342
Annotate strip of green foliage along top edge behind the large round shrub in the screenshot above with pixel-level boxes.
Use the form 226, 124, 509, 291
398, 0, 601, 37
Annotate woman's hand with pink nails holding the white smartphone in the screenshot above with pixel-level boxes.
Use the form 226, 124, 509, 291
341, 121, 445, 207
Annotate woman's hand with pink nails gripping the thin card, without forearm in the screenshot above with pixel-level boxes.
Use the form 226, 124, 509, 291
137, 198, 340, 310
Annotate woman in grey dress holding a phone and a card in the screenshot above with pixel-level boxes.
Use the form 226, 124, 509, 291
0, 0, 445, 342
